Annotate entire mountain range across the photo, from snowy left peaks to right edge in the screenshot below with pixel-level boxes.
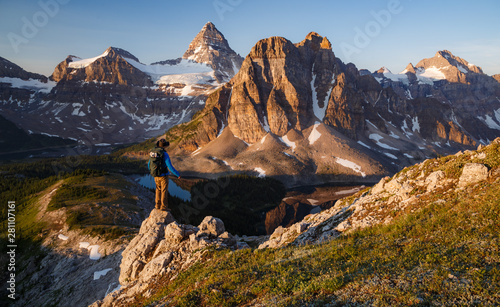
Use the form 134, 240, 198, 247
0, 23, 500, 185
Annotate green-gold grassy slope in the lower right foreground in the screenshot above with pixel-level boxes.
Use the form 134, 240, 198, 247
143, 172, 500, 306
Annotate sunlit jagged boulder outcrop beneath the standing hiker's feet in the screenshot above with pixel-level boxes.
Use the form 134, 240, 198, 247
97, 209, 238, 306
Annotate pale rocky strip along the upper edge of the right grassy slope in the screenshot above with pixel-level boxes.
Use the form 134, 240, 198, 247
259, 138, 500, 249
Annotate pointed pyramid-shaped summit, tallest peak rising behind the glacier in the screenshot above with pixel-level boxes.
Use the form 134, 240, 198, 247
182, 22, 243, 83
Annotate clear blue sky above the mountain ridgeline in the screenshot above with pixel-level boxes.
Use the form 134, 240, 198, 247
0, 0, 500, 75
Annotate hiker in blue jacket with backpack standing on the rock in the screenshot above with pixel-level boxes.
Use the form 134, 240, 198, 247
148, 139, 181, 211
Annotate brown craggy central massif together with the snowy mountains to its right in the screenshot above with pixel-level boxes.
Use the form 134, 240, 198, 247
169, 32, 500, 185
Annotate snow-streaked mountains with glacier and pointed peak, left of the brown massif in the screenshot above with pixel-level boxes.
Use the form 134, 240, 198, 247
0, 23, 241, 145
